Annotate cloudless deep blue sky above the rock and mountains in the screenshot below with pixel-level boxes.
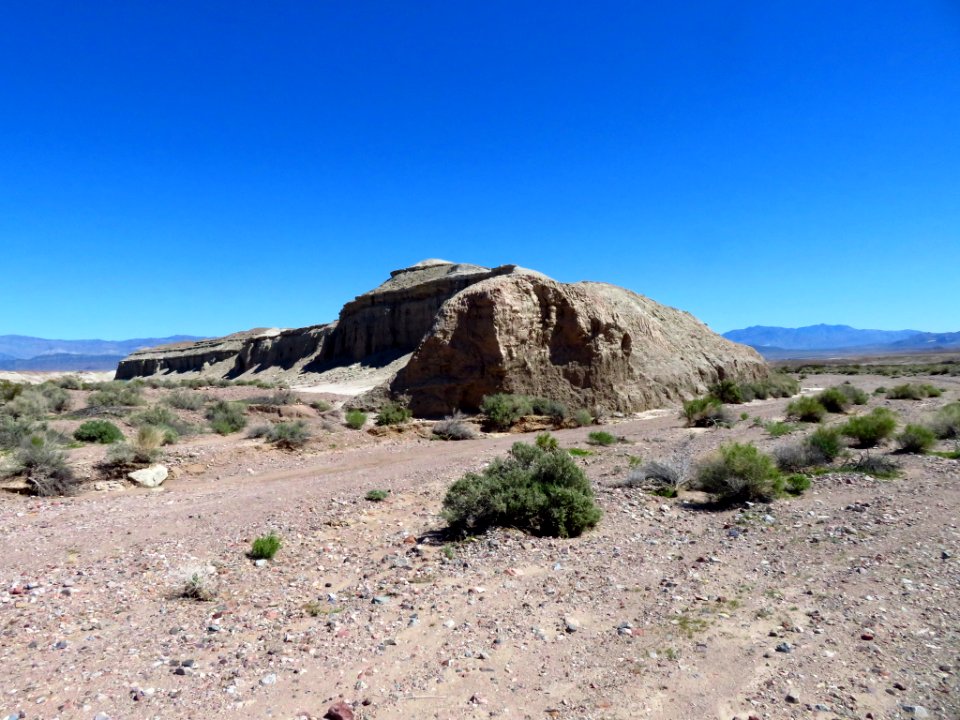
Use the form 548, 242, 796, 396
0, 0, 960, 339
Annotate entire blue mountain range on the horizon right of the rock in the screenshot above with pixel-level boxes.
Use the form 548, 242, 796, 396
723, 325, 960, 360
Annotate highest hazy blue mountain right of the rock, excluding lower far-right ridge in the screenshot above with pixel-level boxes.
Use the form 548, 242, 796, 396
723, 325, 923, 350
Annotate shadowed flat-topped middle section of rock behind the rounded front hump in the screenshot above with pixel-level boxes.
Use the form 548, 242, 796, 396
321, 260, 522, 363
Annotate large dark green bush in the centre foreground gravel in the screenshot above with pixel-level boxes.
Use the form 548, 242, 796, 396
443, 443, 602, 537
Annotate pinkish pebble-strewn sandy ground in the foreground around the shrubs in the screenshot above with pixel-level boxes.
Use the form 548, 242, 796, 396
0, 376, 960, 720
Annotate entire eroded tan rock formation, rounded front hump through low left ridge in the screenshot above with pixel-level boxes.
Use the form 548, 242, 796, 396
117, 260, 767, 416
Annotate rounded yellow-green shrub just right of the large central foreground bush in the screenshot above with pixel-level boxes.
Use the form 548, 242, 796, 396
692, 443, 780, 504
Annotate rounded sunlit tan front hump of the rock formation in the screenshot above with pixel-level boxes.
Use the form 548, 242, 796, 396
391, 271, 767, 416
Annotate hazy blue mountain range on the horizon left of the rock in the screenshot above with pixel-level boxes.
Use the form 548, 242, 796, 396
0, 335, 203, 371
